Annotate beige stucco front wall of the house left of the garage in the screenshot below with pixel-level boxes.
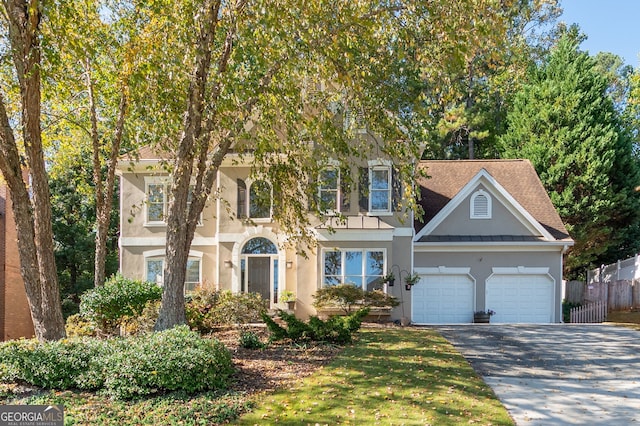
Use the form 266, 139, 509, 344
119, 152, 413, 318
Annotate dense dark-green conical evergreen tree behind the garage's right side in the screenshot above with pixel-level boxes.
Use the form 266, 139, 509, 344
501, 32, 640, 278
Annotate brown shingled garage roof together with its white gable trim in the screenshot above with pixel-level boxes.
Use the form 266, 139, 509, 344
415, 160, 571, 241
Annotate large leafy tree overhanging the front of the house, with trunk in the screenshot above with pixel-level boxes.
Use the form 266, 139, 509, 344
140, 0, 513, 329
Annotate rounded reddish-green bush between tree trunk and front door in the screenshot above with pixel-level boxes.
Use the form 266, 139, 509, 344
185, 288, 267, 333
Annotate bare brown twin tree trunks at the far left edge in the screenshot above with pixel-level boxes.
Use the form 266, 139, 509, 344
0, 0, 65, 340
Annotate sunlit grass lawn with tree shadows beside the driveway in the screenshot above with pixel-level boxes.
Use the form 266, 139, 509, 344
234, 329, 513, 425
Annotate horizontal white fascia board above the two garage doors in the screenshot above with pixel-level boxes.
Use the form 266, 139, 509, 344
413, 241, 567, 253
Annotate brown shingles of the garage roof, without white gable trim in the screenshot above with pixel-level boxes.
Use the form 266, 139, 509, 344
415, 160, 571, 240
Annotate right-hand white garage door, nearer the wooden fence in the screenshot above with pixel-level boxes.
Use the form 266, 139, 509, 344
486, 274, 554, 323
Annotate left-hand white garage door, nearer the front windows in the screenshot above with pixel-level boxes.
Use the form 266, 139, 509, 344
411, 274, 474, 324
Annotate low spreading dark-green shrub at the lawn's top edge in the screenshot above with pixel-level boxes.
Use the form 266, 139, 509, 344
262, 308, 369, 344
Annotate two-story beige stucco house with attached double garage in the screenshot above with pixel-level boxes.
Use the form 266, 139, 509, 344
119, 148, 572, 324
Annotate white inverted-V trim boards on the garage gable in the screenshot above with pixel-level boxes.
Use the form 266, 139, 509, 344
414, 169, 556, 241
